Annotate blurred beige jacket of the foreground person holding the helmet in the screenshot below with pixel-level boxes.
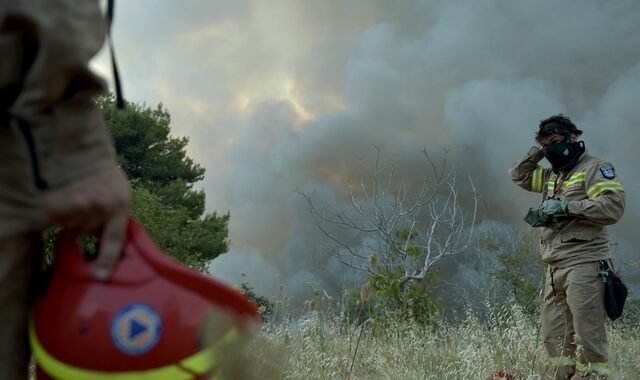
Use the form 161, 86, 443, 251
0, 0, 114, 237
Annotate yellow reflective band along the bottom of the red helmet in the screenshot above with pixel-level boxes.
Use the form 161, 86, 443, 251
29, 321, 213, 380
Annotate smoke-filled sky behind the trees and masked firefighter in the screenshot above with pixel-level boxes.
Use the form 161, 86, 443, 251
94, 0, 640, 299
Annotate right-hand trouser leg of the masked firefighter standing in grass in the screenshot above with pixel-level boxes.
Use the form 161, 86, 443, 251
567, 262, 609, 375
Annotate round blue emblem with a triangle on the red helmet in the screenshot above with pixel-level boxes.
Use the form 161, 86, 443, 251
111, 304, 162, 355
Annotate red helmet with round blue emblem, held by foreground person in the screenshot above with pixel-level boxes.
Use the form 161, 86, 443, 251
29, 218, 259, 380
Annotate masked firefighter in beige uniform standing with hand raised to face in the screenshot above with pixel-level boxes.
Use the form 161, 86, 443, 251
509, 115, 625, 379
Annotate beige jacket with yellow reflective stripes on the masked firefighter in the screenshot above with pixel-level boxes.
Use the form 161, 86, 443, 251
509, 146, 625, 268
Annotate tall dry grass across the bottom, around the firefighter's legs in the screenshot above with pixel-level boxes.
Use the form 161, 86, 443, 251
239, 308, 640, 380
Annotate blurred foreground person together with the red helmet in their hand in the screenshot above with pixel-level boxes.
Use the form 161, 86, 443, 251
0, 0, 259, 380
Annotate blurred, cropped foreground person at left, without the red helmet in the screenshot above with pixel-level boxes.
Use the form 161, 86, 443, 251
0, 0, 129, 380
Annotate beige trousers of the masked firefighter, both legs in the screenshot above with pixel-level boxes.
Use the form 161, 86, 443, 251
541, 261, 609, 380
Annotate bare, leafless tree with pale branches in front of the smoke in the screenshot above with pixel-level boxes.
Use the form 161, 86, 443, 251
301, 147, 478, 286
